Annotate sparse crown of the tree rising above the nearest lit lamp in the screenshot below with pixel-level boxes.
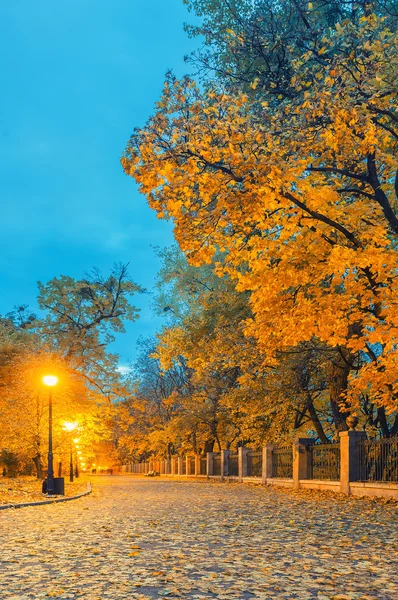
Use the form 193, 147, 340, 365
34, 264, 142, 385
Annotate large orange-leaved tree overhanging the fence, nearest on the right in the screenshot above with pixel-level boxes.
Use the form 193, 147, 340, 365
122, 2, 398, 435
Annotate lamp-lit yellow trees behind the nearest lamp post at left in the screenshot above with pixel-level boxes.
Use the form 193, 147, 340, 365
0, 265, 140, 477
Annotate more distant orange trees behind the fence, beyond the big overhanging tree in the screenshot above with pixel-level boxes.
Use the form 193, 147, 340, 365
112, 247, 366, 460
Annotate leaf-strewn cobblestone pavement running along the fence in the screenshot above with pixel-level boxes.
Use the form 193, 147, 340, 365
0, 476, 398, 600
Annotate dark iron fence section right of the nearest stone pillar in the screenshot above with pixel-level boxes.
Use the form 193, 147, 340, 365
357, 437, 398, 482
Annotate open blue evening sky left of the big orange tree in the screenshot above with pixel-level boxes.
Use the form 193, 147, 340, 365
0, 0, 198, 364
